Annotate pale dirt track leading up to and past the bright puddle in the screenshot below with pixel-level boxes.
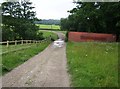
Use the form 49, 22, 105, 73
2, 33, 70, 87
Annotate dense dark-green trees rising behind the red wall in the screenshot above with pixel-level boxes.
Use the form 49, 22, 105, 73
61, 1, 120, 41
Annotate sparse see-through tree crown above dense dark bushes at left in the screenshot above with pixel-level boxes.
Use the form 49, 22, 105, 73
1, 0, 35, 20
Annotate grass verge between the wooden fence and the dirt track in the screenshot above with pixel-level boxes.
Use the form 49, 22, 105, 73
2, 42, 50, 74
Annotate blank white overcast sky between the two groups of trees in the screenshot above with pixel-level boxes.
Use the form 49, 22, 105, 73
30, 0, 75, 19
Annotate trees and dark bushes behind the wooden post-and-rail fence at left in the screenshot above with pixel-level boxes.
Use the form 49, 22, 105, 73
0, 0, 43, 41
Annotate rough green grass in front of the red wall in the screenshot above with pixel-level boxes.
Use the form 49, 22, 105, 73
67, 42, 120, 87
